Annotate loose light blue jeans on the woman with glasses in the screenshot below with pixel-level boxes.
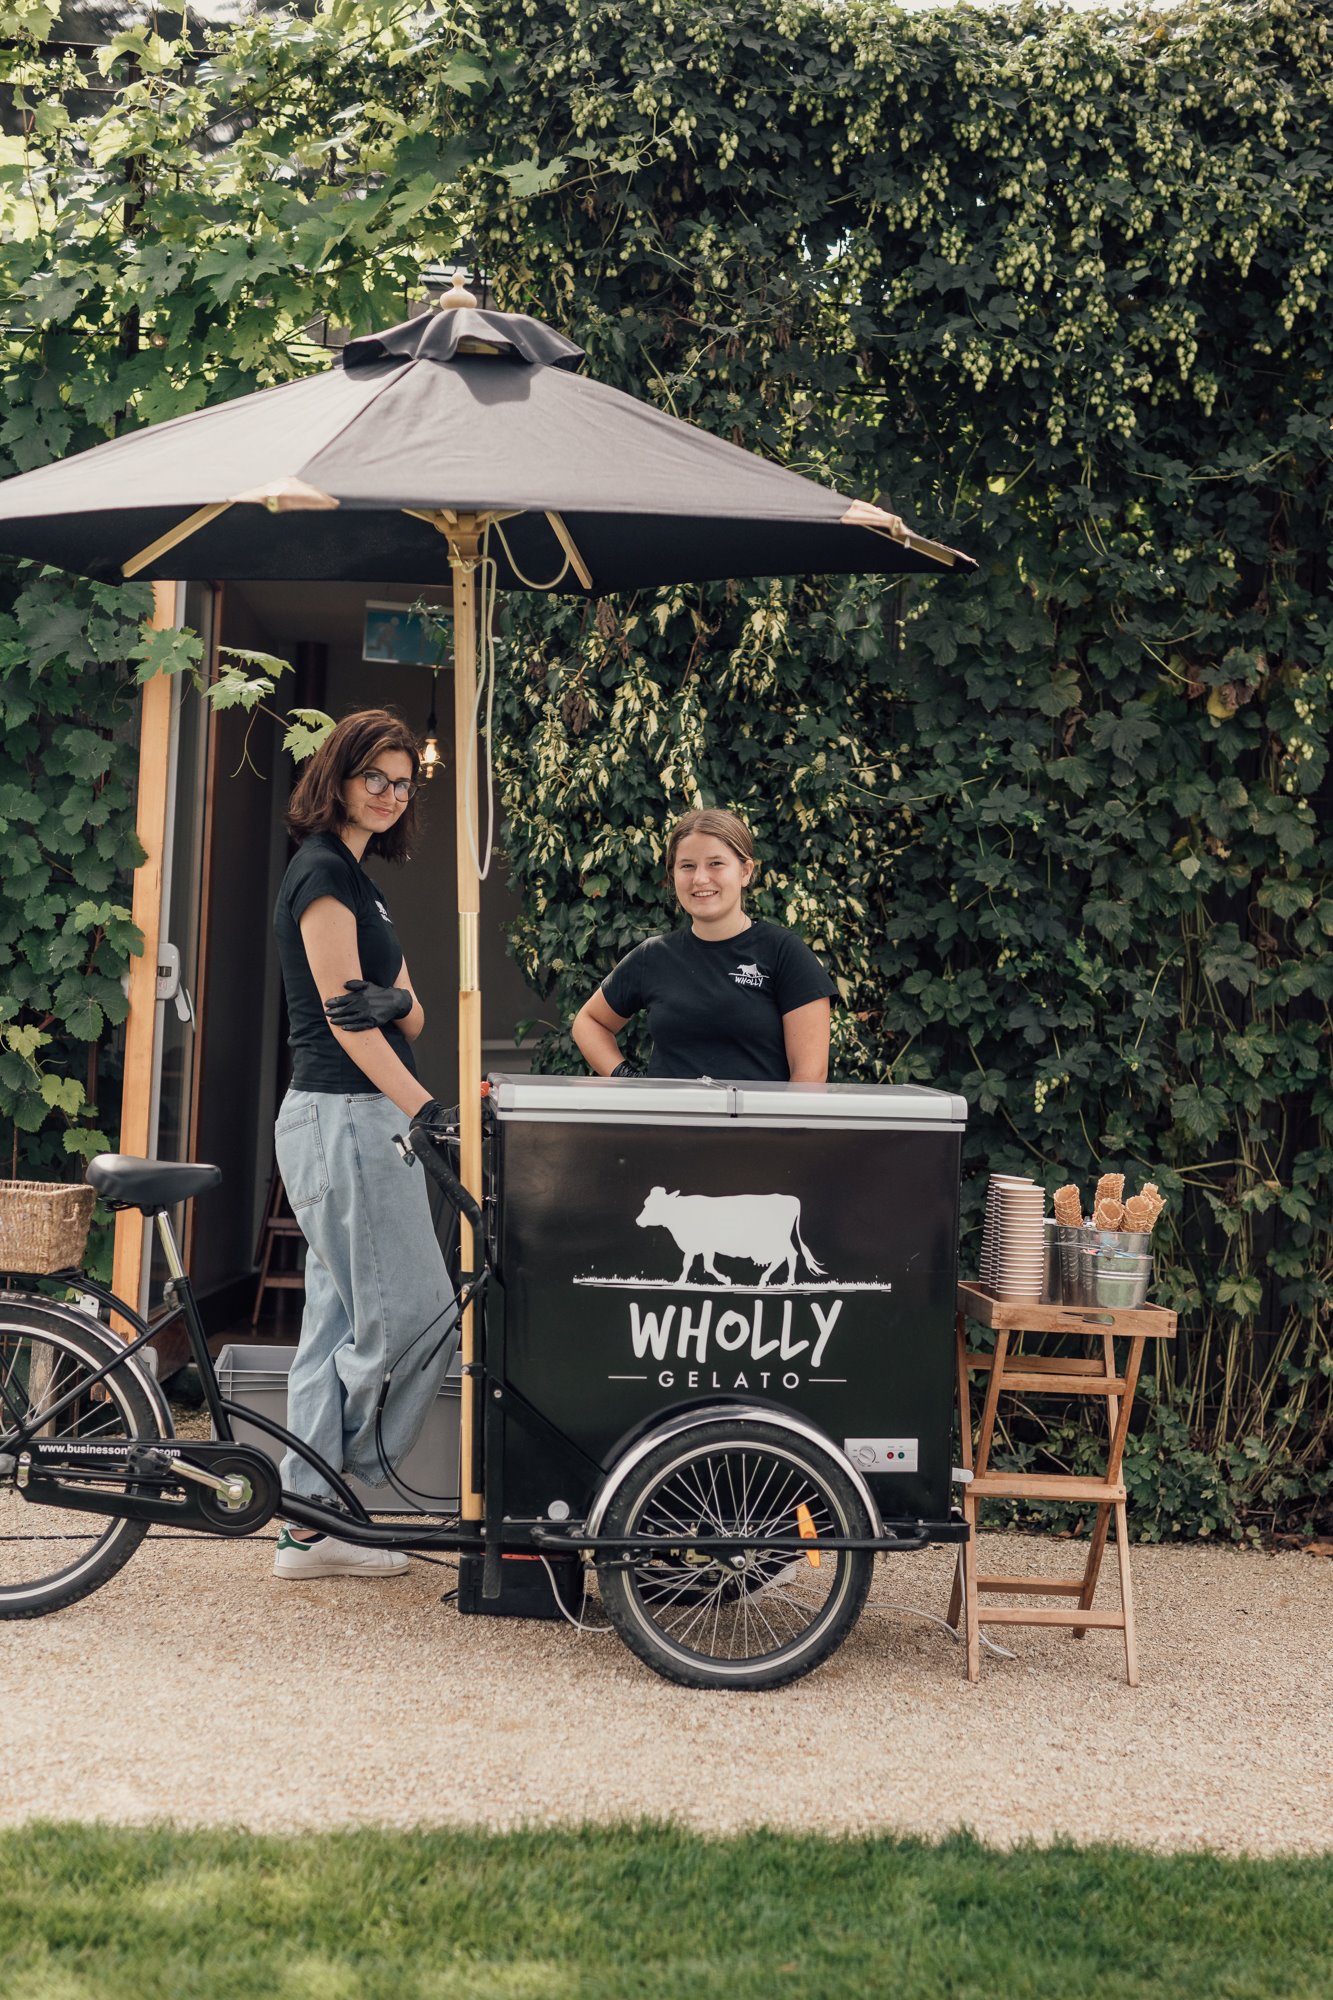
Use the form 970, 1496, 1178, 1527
276, 1090, 458, 1500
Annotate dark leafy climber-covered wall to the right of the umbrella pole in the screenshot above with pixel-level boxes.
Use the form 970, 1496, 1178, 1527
460, 0, 1333, 1534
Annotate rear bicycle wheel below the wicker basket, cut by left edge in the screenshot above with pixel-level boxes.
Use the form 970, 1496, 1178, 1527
0, 1302, 162, 1618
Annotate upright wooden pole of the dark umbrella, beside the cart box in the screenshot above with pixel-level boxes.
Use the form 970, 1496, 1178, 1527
446, 514, 482, 1520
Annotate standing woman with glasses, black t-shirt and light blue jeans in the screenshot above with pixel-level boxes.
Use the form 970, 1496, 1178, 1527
274, 708, 456, 1578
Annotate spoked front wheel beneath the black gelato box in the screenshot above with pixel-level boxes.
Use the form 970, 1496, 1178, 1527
598, 1420, 875, 1688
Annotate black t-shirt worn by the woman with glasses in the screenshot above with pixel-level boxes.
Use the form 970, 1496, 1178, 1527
272, 834, 416, 1092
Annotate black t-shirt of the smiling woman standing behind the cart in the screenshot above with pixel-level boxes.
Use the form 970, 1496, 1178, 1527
602, 920, 837, 1084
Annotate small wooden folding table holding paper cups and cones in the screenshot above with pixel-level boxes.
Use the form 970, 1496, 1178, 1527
949, 1284, 1175, 1688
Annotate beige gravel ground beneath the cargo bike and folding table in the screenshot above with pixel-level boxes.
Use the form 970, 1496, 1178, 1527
0, 1536, 1333, 1854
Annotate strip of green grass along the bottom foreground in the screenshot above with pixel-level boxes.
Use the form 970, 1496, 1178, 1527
0, 1832, 1333, 2000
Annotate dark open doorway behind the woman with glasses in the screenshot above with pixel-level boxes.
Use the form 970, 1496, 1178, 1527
154, 582, 542, 1338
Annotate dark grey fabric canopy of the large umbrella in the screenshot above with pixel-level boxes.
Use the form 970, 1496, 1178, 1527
0, 306, 973, 594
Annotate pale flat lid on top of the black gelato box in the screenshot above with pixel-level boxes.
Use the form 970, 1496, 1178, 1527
490, 1074, 967, 1128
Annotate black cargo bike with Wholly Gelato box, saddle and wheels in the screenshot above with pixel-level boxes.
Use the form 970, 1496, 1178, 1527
0, 1076, 967, 1688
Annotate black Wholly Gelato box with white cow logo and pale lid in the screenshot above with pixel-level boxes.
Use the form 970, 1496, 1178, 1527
490, 1076, 967, 1522
